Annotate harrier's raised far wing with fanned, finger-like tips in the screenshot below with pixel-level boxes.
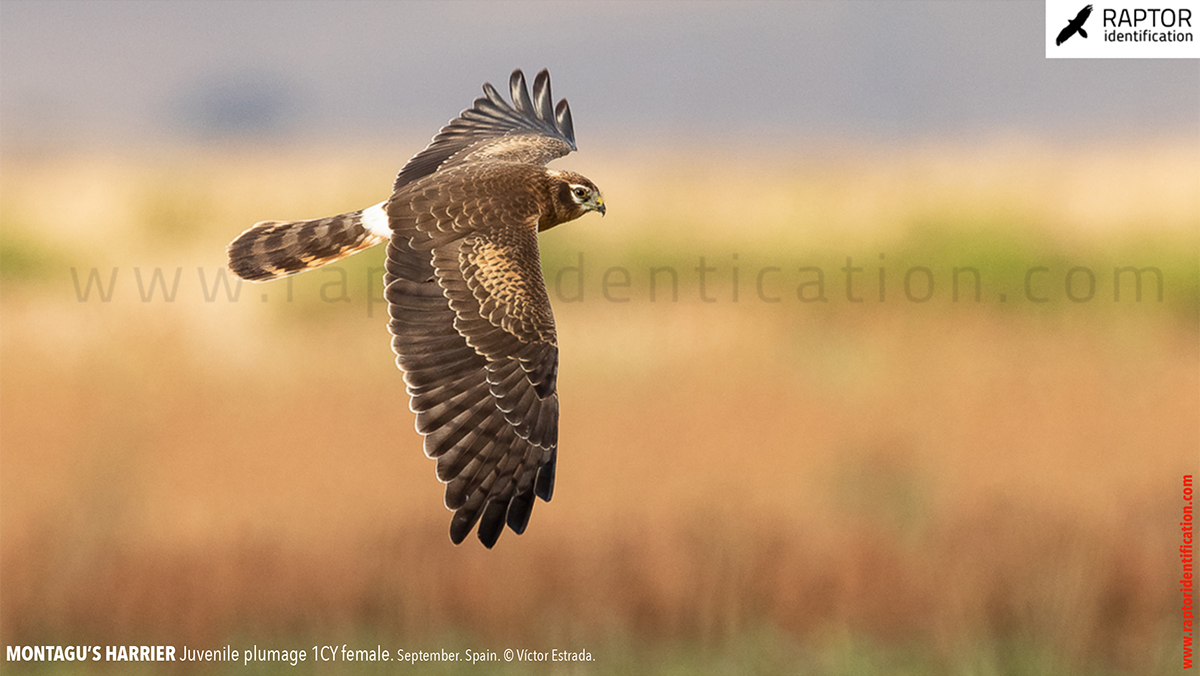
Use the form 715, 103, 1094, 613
392, 70, 575, 191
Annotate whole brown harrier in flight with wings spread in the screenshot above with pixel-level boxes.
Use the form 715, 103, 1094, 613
228, 70, 605, 548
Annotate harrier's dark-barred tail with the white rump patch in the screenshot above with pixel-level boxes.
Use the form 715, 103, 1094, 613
228, 204, 390, 281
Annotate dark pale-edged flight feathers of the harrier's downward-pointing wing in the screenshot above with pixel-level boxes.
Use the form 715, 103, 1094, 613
385, 229, 558, 548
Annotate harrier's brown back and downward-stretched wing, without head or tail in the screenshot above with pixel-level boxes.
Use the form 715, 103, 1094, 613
384, 167, 558, 548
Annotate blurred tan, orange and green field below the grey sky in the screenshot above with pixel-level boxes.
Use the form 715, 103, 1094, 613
0, 142, 1200, 675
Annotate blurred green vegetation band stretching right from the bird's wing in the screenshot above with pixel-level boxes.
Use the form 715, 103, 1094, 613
542, 223, 1200, 322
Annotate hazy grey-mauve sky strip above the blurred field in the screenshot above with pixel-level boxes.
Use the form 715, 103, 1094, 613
0, 0, 1200, 145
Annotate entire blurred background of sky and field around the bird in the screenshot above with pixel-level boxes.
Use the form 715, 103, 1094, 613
0, 0, 1200, 675
